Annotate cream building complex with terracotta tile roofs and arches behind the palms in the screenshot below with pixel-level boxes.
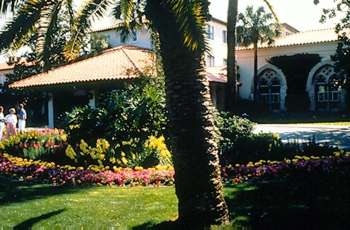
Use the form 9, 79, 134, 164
8, 18, 346, 127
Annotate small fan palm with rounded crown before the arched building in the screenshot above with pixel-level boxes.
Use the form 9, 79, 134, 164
237, 6, 280, 101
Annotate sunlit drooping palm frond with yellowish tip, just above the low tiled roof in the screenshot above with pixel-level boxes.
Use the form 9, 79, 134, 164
65, 0, 113, 60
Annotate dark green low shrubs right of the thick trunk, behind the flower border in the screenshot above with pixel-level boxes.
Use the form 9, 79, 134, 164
217, 113, 337, 165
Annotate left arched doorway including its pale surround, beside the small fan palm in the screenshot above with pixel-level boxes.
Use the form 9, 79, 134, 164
257, 64, 287, 111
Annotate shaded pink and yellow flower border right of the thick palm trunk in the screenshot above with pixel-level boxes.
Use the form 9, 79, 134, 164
223, 153, 350, 184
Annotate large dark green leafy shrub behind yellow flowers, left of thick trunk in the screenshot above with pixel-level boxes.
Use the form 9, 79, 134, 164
65, 78, 166, 165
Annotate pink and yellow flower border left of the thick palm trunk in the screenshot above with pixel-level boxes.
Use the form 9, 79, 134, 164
0, 154, 174, 186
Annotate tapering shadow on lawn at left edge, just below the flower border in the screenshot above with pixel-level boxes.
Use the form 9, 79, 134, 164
0, 175, 91, 206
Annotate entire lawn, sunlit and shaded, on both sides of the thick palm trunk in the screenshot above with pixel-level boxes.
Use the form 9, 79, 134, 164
0, 174, 350, 230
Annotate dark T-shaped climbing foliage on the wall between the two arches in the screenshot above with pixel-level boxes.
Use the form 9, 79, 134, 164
267, 54, 321, 111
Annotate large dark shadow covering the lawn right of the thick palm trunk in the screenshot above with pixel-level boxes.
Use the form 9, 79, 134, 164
134, 173, 350, 230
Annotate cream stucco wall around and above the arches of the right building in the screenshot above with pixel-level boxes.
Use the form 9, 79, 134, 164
237, 42, 337, 99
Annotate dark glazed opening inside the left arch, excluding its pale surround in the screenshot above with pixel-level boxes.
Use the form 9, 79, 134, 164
258, 69, 281, 111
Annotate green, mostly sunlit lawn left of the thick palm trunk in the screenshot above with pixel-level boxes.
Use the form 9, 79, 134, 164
0, 176, 177, 229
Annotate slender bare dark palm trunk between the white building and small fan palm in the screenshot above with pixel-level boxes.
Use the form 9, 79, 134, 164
225, 0, 238, 112
